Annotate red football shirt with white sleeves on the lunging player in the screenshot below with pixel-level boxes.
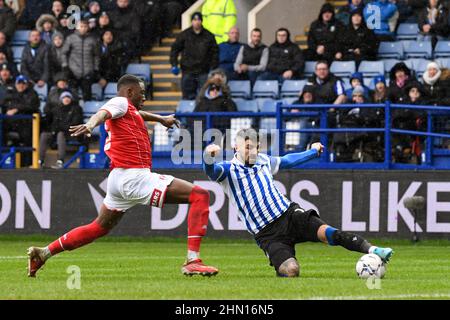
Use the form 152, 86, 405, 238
100, 97, 152, 169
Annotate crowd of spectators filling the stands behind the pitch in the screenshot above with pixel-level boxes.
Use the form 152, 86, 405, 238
0, 0, 450, 167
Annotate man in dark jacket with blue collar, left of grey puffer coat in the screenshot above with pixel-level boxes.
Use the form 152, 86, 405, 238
20, 30, 50, 87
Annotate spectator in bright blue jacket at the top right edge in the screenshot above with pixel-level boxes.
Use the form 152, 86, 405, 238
364, 0, 398, 41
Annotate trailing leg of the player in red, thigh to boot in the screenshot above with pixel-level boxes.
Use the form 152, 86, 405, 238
28, 205, 124, 277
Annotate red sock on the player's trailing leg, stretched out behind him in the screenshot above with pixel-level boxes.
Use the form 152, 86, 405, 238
48, 220, 109, 256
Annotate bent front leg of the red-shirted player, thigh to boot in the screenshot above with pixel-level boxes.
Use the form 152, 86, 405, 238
164, 178, 218, 275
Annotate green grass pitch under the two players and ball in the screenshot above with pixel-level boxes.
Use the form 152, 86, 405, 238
0, 236, 450, 300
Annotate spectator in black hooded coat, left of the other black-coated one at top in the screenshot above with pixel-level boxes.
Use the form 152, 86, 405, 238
307, 3, 344, 62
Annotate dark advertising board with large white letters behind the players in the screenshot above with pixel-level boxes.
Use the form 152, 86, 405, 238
0, 170, 450, 239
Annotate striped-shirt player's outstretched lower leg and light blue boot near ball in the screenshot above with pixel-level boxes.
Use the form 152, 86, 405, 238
316, 224, 394, 262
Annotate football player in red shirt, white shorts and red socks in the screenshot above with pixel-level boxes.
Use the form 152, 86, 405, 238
28, 75, 218, 277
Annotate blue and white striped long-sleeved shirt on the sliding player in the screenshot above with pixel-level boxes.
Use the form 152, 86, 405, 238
204, 150, 317, 235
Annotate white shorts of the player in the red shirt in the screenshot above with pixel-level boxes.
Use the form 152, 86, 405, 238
103, 168, 174, 211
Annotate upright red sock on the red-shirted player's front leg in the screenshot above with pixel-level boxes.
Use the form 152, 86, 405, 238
188, 186, 209, 252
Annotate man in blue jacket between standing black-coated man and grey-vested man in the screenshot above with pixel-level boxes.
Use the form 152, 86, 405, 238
219, 27, 242, 80
